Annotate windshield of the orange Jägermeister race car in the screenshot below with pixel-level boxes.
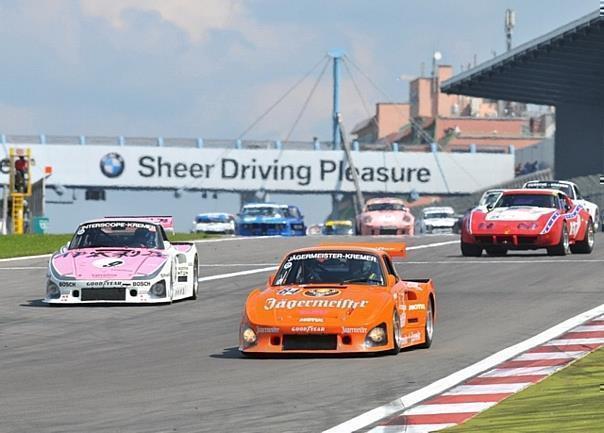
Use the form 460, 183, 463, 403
274, 251, 384, 286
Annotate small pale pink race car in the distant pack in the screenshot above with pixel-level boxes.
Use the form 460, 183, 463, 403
356, 198, 415, 235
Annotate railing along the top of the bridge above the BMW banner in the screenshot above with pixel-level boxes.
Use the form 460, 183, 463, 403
0, 134, 514, 153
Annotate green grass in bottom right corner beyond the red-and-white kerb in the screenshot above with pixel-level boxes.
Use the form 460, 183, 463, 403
441, 348, 604, 433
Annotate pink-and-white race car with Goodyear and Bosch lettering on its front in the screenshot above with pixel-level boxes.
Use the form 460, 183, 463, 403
44, 217, 199, 305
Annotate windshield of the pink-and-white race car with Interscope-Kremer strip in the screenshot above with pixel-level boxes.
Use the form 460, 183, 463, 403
69, 221, 163, 250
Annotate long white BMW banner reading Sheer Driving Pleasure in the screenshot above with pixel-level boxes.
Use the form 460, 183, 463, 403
0, 145, 514, 193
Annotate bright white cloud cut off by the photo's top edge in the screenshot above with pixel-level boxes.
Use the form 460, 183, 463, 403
80, 0, 248, 42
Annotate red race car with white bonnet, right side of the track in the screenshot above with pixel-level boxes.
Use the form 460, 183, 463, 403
461, 189, 594, 257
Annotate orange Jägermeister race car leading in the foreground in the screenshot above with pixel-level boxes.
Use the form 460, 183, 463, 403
239, 243, 436, 355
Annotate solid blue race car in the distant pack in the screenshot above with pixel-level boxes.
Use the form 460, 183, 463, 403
235, 203, 306, 236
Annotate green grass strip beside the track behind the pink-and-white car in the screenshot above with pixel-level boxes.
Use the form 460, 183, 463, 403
0, 233, 214, 259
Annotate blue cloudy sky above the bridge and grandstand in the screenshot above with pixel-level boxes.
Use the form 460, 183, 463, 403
0, 0, 598, 140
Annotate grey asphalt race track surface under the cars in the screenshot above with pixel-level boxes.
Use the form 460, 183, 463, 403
0, 234, 604, 433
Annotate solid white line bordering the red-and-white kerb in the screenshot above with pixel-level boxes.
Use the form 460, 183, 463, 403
325, 304, 604, 433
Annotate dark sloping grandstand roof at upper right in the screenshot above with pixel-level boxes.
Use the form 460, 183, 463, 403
442, 11, 604, 106
